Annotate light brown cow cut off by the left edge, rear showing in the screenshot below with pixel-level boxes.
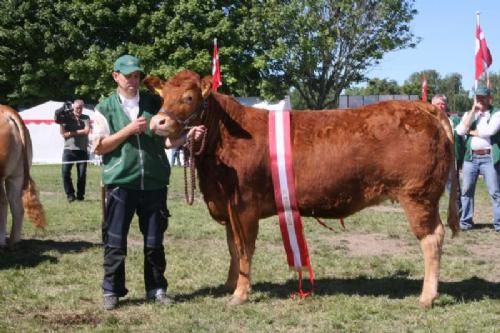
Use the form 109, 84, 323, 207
0, 105, 46, 248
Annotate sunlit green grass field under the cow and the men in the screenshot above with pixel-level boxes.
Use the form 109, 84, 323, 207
0, 166, 500, 332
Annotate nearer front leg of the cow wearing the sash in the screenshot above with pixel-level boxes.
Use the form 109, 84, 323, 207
228, 214, 259, 306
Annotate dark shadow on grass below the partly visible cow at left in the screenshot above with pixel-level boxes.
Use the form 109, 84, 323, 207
0, 239, 100, 270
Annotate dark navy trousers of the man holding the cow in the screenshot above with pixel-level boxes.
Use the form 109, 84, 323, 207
102, 187, 169, 297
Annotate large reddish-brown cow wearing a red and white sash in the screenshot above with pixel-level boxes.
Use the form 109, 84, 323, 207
145, 71, 459, 307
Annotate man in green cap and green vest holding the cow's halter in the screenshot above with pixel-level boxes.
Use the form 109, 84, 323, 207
92, 55, 204, 310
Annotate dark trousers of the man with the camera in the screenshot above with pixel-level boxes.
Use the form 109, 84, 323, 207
61, 149, 88, 199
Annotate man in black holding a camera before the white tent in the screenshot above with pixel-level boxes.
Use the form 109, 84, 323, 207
56, 99, 90, 202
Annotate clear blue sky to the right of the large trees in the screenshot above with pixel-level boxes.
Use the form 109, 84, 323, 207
367, 0, 500, 90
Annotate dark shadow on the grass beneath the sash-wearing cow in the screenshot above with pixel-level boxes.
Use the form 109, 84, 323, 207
176, 276, 500, 303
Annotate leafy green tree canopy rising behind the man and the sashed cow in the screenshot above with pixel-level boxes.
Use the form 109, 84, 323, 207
0, 0, 418, 109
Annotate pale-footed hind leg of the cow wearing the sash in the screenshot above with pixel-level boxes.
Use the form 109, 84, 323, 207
400, 198, 444, 308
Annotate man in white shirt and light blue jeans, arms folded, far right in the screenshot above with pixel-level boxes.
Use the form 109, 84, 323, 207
456, 87, 500, 232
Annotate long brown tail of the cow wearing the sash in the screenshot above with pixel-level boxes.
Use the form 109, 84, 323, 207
420, 104, 460, 237
